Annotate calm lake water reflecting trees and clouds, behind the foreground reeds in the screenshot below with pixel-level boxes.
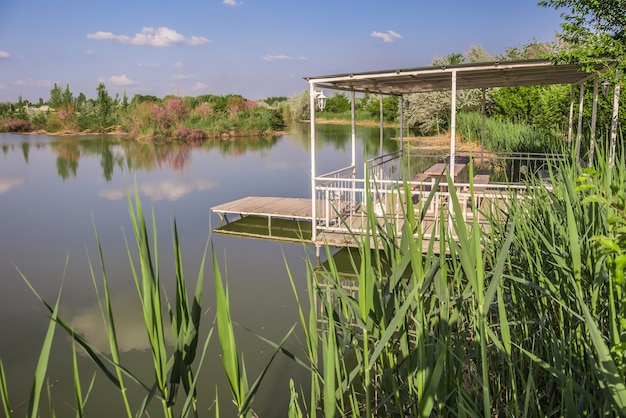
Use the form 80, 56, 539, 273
0, 124, 398, 417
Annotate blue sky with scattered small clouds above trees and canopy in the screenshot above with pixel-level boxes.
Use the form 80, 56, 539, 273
0, 0, 561, 102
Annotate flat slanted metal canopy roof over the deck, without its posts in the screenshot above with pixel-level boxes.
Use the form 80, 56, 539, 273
306, 60, 604, 95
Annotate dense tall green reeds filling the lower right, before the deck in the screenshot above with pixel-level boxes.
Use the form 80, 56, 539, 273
284, 142, 626, 417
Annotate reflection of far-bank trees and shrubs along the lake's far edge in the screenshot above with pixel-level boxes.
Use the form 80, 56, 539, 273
0, 124, 398, 182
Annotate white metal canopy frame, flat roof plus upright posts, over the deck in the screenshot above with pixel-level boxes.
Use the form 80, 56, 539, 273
305, 60, 620, 242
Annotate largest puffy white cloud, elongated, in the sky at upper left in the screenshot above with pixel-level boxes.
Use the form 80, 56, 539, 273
87, 26, 211, 47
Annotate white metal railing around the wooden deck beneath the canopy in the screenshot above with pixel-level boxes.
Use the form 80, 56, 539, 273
315, 152, 564, 243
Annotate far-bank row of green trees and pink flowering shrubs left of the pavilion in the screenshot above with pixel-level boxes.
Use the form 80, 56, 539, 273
0, 82, 287, 142
